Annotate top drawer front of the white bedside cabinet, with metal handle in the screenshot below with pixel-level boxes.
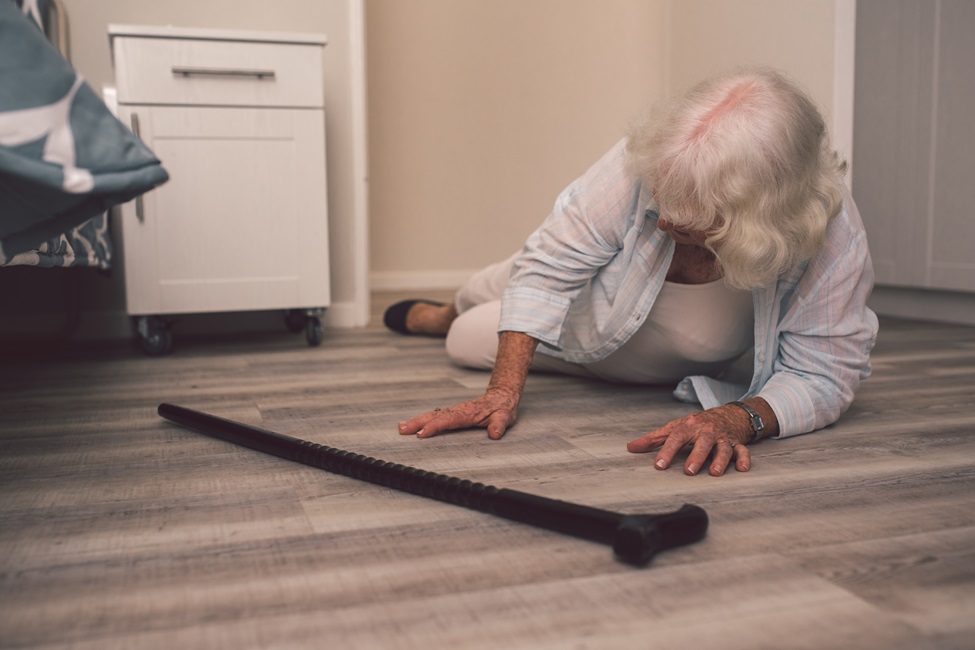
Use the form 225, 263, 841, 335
112, 36, 324, 108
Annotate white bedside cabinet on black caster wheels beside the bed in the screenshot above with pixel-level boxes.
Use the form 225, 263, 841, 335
109, 25, 330, 352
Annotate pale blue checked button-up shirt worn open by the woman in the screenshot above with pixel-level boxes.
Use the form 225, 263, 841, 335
499, 141, 877, 437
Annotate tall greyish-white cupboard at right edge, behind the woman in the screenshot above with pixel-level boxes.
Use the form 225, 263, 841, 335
853, 0, 975, 293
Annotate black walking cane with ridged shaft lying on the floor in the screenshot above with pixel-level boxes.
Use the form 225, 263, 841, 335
159, 404, 708, 565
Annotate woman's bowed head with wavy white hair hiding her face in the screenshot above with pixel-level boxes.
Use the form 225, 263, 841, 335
627, 68, 845, 288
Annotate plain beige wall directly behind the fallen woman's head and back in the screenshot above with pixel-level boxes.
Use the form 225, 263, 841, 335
367, 0, 852, 288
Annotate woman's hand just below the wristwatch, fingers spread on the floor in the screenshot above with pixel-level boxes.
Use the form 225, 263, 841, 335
626, 405, 767, 476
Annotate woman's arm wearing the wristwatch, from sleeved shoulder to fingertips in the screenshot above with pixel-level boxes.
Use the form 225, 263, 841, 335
627, 198, 877, 475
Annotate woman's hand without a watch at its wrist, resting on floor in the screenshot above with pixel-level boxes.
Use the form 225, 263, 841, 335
399, 387, 521, 440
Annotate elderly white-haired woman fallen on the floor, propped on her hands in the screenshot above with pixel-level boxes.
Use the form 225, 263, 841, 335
385, 69, 877, 476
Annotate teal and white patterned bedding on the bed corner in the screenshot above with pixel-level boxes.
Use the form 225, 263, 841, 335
0, 0, 168, 266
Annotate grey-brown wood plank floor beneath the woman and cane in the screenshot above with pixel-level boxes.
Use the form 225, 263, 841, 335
0, 295, 975, 650
